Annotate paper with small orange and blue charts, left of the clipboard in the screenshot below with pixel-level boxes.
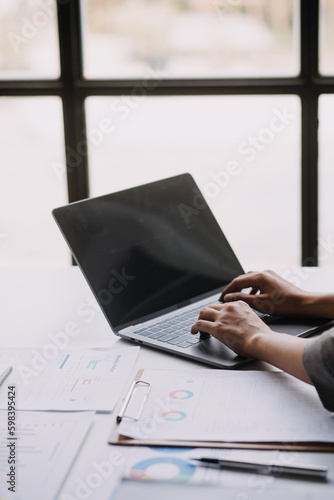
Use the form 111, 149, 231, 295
0, 347, 139, 411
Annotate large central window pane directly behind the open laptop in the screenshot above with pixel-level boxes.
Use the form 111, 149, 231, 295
86, 96, 300, 269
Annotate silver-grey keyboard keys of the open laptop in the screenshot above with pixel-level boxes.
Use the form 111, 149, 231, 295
133, 299, 268, 349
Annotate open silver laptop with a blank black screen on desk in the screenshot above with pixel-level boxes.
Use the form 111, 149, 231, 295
52, 174, 334, 369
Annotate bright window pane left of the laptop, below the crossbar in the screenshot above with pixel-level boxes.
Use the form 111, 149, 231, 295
0, 97, 70, 266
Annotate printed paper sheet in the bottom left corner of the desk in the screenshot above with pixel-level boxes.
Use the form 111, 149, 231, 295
0, 411, 94, 500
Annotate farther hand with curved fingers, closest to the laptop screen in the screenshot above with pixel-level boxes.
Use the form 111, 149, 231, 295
219, 271, 308, 316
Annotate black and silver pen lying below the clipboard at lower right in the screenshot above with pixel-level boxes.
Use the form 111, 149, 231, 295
191, 457, 328, 479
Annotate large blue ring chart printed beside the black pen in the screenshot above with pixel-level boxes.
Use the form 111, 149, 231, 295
130, 457, 196, 482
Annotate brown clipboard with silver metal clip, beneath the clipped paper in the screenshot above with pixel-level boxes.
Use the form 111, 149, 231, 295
108, 369, 334, 452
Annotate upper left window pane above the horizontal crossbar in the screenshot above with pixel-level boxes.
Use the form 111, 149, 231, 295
0, 0, 60, 79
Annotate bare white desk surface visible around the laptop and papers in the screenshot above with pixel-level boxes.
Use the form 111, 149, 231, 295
0, 267, 334, 500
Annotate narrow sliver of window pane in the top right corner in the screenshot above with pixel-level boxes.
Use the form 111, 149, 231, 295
319, 0, 334, 75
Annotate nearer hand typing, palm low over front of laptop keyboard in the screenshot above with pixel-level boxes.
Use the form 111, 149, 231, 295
191, 301, 273, 358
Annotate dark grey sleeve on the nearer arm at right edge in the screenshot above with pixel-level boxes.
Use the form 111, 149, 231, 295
303, 328, 334, 411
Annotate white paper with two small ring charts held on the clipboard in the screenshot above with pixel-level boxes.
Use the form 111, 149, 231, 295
119, 370, 334, 443
